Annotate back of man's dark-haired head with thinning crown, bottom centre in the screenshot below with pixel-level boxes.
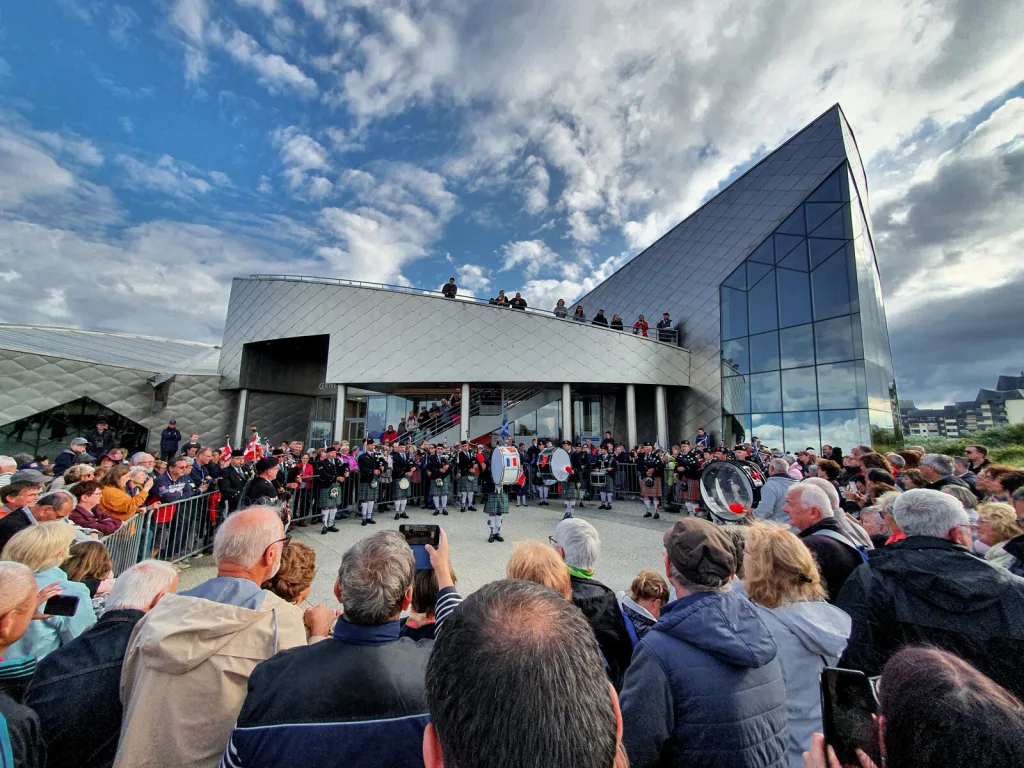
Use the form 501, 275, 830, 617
419, 581, 629, 768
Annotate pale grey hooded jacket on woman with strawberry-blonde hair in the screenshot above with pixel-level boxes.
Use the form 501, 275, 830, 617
754, 602, 851, 768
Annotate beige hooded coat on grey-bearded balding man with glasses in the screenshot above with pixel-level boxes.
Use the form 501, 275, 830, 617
114, 593, 306, 768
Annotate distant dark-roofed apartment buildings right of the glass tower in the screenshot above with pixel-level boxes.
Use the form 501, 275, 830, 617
899, 374, 1024, 438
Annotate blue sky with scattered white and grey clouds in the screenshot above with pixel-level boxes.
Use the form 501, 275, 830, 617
0, 0, 1024, 406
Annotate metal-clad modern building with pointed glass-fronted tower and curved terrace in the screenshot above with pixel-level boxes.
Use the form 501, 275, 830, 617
0, 105, 902, 451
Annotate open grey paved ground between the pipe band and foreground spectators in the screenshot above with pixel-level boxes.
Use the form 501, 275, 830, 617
179, 501, 679, 606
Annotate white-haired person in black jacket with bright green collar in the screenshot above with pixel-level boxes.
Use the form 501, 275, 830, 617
552, 517, 633, 690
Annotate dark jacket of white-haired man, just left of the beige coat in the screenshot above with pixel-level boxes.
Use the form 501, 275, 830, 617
27, 609, 145, 768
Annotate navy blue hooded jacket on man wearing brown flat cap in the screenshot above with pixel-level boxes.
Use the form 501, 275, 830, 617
621, 592, 788, 768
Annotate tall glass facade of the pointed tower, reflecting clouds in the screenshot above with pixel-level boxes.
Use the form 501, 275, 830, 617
720, 163, 902, 452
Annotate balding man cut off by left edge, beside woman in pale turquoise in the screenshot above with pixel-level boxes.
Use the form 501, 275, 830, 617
0, 562, 47, 768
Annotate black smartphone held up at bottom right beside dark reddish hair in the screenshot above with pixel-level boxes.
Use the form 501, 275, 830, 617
821, 667, 882, 766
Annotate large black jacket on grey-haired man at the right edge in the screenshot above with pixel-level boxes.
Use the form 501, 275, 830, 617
838, 536, 1024, 698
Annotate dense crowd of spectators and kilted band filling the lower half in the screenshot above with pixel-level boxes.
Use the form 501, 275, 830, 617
0, 422, 1024, 768
